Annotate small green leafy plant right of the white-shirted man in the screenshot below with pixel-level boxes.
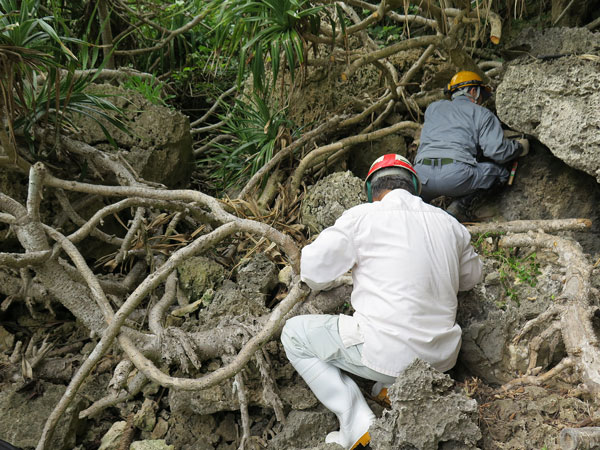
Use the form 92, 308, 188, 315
474, 233, 541, 307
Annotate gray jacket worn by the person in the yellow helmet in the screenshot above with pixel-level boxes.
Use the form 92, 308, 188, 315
415, 95, 520, 165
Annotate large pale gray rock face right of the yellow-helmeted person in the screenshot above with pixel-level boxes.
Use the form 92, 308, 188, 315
496, 29, 600, 181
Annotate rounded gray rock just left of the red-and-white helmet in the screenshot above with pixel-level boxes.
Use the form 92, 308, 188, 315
300, 171, 367, 233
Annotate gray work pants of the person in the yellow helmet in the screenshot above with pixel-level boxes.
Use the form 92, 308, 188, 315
414, 159, 509, 202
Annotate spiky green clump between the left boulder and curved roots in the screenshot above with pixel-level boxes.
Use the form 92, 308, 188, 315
198, 94, 292, 190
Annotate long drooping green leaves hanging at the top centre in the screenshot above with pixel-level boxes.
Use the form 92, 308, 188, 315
212, 0, 322, 91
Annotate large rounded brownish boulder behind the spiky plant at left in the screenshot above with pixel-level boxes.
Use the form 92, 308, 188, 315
75, 84, 194, 187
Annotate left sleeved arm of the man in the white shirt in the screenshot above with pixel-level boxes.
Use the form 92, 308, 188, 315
300, 216, 356, 291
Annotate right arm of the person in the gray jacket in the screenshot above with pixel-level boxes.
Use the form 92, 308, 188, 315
479, 108, 521, 164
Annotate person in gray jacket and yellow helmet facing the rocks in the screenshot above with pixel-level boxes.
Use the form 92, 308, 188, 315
414, 71, 529, 220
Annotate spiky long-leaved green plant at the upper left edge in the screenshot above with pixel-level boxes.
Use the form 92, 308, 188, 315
0, 0, 125, 157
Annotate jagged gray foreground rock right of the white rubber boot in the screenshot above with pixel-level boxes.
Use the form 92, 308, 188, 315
370, 360, 481, 450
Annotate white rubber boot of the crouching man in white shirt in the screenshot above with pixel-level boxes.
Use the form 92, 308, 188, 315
292, 358, 375, 450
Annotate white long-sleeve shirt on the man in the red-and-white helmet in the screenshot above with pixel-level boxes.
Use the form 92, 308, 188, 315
301, 189, 482, 376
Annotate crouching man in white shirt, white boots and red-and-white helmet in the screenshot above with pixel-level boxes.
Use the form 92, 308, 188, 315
281, 154, 482, 449
